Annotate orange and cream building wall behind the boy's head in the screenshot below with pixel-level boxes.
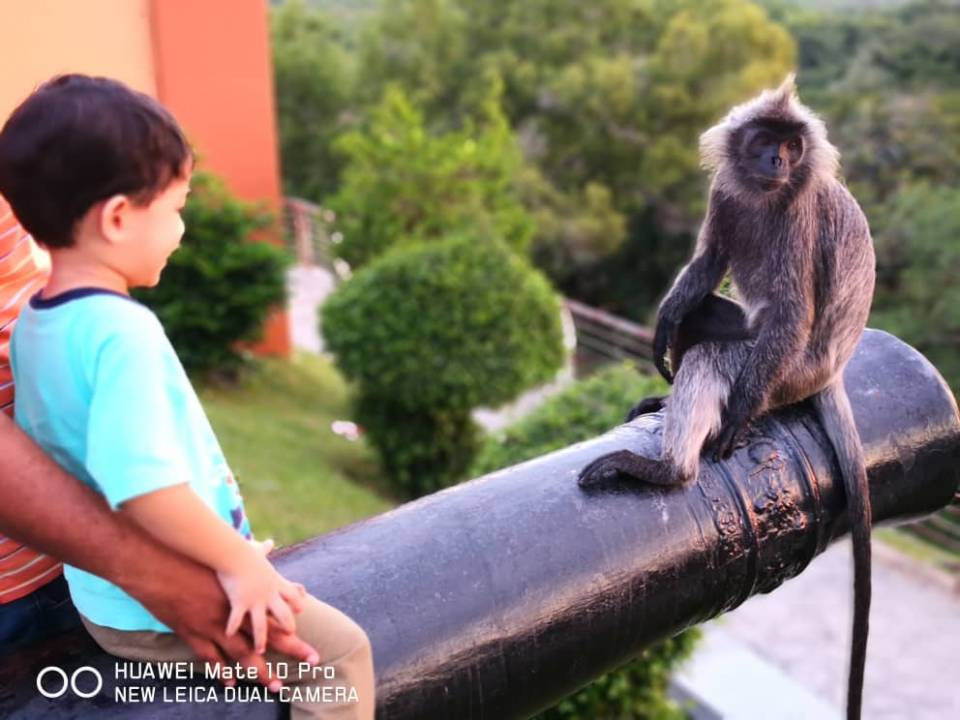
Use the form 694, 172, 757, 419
0, 0, 290, 354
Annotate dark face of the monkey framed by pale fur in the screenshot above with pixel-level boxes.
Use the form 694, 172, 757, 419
736, 120, 804, 192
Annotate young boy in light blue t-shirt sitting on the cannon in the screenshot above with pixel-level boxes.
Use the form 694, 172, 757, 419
0, 75, 374, 718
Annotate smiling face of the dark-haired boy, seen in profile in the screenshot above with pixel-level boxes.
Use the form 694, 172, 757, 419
122, 171, 190, 287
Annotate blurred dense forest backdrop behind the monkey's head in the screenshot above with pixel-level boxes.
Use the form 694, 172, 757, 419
272, 0, 960, 384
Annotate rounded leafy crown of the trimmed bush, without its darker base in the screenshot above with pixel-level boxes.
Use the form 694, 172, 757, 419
323, 236, 563, 410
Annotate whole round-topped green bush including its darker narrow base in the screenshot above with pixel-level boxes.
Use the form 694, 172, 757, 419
323, 235, 563, 495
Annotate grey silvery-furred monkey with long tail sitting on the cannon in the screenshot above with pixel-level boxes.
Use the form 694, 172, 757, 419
578, 74, 875, 720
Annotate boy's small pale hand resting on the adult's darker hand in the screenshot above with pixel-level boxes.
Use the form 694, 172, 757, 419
217, 543, 306, 653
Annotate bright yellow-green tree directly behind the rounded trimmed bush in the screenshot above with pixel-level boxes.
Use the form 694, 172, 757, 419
327, 87, 535, 267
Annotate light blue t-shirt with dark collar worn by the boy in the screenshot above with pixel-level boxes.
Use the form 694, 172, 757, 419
10, 288, 250, 632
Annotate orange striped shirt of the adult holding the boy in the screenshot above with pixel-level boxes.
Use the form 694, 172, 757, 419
0, 197, 63, 605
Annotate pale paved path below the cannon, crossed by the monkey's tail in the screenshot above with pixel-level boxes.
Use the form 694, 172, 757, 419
707, 541, 960, 720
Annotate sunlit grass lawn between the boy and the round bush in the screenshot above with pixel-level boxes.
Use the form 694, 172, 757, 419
199, 354, 394, 545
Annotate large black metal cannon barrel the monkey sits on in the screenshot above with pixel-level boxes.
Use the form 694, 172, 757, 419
0, 331, 960, 720
